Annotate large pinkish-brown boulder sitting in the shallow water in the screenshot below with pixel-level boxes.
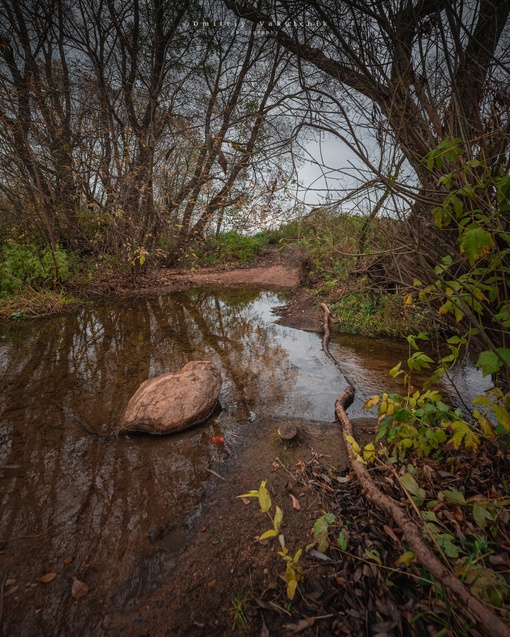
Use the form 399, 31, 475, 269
120, 361, 221, 434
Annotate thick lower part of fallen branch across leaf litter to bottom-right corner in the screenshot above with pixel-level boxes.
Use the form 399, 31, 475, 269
335, 386, 510, 637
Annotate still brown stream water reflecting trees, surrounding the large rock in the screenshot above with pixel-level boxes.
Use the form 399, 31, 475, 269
0, 290, 488, 635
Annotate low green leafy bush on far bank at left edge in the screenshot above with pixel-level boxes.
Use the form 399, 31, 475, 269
0, 241, 73, 294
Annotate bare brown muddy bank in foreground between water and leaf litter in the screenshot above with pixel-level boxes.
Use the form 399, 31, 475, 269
103, 418, 370, 637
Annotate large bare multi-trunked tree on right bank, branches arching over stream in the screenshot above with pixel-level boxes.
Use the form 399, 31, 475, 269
224, 0, 510, 358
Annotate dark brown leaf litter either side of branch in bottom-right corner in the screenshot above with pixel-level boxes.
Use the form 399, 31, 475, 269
253, 448, 510, 637
